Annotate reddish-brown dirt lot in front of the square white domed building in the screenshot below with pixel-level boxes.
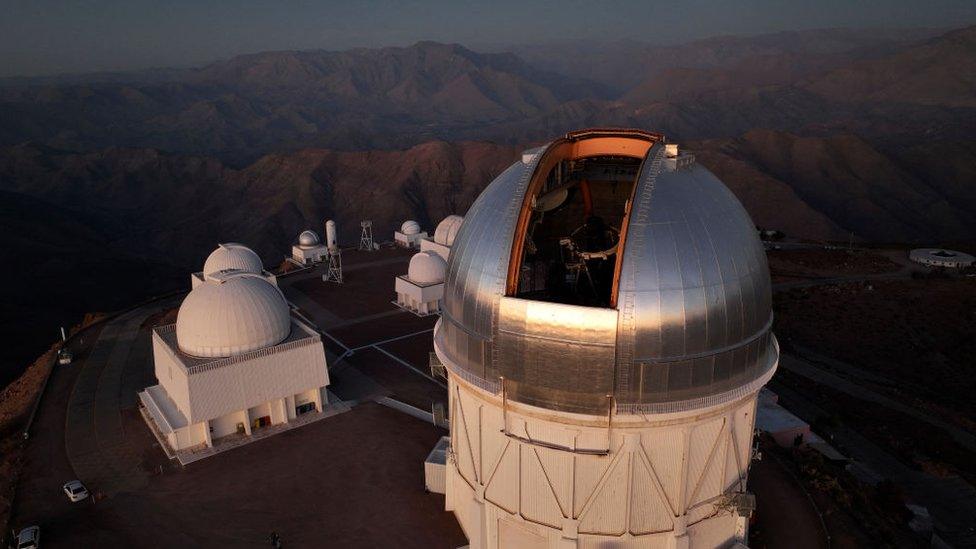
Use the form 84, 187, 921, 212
10, 403, 465, 548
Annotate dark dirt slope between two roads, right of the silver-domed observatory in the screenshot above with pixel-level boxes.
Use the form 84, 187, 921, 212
773, 278, 976, 420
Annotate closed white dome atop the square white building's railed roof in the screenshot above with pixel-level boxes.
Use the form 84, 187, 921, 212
176, 276, 291, 357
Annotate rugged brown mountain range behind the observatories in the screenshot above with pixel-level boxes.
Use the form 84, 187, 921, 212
0, 27, 976, 384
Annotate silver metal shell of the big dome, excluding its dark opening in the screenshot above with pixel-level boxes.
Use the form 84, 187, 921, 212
435, 130, 778, 414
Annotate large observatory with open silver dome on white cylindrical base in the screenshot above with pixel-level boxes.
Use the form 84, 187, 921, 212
434, 129, 779, 549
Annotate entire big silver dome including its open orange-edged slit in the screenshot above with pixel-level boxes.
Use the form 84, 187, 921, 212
435, 130, 778, 414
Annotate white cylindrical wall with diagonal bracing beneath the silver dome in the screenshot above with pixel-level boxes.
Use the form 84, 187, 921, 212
446, 375, 756, 549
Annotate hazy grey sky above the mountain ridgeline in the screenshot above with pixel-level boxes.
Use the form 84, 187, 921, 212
0, 0, 976, 76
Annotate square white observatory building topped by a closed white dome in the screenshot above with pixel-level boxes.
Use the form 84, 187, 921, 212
139, 252, 329, 454
